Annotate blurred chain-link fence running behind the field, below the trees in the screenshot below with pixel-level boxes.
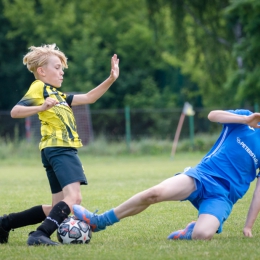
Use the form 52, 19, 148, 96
0, 106, 228, 144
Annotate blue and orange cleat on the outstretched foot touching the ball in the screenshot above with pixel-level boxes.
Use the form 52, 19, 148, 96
73, 205, 106, 232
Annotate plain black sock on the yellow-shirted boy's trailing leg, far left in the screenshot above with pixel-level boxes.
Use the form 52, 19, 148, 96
2, 205, 46, 231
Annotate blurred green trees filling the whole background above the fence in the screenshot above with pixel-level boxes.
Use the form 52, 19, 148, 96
0, 0, 260, 110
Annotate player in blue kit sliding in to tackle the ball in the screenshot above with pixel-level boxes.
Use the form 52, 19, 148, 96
73, 110, 260, 240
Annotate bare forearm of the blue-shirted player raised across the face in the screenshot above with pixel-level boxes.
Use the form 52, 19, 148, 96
208, 110, 260, 128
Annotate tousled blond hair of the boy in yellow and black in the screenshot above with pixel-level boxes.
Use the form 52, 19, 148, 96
23, 43, 68, 73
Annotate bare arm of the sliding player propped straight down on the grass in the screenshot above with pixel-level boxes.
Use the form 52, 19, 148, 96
243, 178, 260, 237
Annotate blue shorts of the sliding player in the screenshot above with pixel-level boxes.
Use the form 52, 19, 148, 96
183, 168, 233, 233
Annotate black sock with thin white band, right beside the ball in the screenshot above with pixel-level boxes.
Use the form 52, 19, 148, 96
37, 201, 70, 237
